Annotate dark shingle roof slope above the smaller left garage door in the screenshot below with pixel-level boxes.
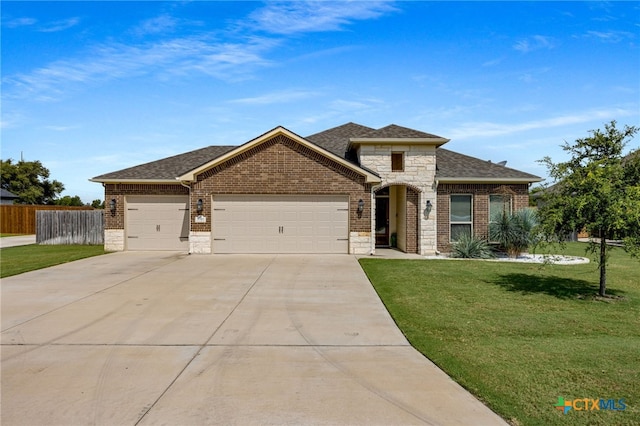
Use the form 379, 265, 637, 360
93, 145, 236, 181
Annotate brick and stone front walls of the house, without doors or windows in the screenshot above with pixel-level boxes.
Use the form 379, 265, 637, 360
104, 127, 529, 255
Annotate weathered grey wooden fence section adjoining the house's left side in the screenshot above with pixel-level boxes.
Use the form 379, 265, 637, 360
36, 210, 104, 245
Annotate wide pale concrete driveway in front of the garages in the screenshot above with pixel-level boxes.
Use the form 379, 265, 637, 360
1, 252, 505, 425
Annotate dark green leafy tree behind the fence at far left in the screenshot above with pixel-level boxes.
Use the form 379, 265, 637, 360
0, 159, 64, 204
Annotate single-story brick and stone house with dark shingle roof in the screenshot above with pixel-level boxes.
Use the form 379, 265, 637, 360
91, 123, 541, 255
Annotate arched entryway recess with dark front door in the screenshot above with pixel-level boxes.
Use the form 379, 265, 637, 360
374, 184, 419, 253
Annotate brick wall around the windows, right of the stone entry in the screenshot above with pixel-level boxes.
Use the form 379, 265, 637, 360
437, 183, 529, 253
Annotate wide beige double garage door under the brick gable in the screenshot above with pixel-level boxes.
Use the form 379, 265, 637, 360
213, 195, 349, 253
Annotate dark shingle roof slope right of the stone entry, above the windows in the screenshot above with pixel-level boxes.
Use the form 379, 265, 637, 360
436, 148, 540, 181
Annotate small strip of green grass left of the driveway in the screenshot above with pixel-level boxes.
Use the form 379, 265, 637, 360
0, 244, 106, 278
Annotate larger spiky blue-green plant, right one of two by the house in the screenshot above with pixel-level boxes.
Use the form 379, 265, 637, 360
489, 208, 538, 257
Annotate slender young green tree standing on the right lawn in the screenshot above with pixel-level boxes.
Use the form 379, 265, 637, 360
539, 121, 640, 296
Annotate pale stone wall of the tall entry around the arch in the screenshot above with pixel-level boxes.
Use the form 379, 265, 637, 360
358, 142, 437, 255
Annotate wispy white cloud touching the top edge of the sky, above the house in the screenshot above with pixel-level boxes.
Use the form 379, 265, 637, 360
250, 0, 397, 34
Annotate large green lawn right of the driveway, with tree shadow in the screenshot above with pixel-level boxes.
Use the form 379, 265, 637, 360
360, 243, 640, 425
